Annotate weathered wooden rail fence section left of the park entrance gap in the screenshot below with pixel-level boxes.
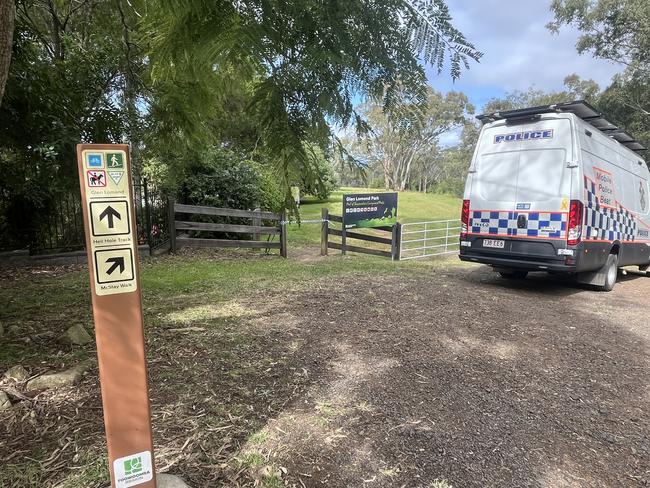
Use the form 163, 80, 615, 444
169, 201, 287, 258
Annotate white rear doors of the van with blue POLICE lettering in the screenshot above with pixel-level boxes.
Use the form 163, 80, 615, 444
470, 116, 573, 241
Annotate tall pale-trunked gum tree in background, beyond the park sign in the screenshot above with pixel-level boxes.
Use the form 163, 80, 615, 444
356, 88, 474, 191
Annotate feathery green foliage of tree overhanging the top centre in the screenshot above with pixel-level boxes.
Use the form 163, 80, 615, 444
145, 0, 481, 201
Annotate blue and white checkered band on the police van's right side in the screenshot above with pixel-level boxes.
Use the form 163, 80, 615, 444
584, 177, 637, 241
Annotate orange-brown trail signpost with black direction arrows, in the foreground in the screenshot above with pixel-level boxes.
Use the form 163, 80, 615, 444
77, 144, 156, 488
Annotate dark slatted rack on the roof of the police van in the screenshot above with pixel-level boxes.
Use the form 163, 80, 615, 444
476, 100, 646, 152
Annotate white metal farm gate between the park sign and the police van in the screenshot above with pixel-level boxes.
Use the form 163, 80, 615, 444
399, 219, 460, 261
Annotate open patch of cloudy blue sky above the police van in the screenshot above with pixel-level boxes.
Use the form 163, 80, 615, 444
427, 0, 622, 113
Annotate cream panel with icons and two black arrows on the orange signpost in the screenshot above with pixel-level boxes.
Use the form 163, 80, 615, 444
82, 149, 138, 296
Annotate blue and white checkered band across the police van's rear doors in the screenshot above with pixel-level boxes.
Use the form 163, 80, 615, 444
470, 210, 567, 239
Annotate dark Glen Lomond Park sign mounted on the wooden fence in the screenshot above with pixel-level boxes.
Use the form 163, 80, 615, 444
343, 193, 397, 229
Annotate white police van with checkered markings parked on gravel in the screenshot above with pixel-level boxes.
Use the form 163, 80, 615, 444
460, 101, 650, 291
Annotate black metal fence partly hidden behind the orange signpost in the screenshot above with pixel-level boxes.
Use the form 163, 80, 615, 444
29, 179, 169, 254
